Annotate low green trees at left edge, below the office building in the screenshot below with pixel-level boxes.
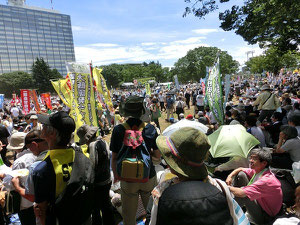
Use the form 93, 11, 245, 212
0, 71, 34, 97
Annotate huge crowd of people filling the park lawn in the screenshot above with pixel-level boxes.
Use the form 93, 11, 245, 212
0, 73, 300, 225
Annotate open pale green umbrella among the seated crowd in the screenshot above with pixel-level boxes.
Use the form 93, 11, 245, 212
208, 124, 260, 158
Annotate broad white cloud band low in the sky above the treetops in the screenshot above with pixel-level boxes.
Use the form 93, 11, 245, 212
75, 37, 208, 65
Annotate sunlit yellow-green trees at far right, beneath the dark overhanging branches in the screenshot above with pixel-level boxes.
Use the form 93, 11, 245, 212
246, 47, 300, 74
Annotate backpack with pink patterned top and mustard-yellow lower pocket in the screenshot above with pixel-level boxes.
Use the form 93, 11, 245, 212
117, 123, 151, 183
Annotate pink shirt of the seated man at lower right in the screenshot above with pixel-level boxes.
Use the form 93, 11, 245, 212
242, 168, 282, 216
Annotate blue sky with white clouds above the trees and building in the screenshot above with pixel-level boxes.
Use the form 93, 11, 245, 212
0, 0, 262, 67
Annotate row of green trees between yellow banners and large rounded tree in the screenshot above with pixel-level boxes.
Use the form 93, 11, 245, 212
101, 61, 170, 87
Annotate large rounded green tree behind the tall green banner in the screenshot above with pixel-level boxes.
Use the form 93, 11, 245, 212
172, 47, 239, 82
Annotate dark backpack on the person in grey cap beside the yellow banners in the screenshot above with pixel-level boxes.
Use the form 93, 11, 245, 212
89, 137, 111, 186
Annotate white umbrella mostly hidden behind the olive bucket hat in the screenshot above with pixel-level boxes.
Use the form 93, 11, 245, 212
162, 119, 208, 137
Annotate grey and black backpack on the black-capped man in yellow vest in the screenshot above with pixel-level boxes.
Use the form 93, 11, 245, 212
52, 146, 94, 225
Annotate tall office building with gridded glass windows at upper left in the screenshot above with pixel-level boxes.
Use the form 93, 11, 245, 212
0, 0, 75, 76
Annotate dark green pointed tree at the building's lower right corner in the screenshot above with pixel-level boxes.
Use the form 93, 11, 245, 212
31, 58, 62, 92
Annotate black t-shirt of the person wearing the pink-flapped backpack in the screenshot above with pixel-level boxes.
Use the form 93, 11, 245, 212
110, 118, 158, 178
